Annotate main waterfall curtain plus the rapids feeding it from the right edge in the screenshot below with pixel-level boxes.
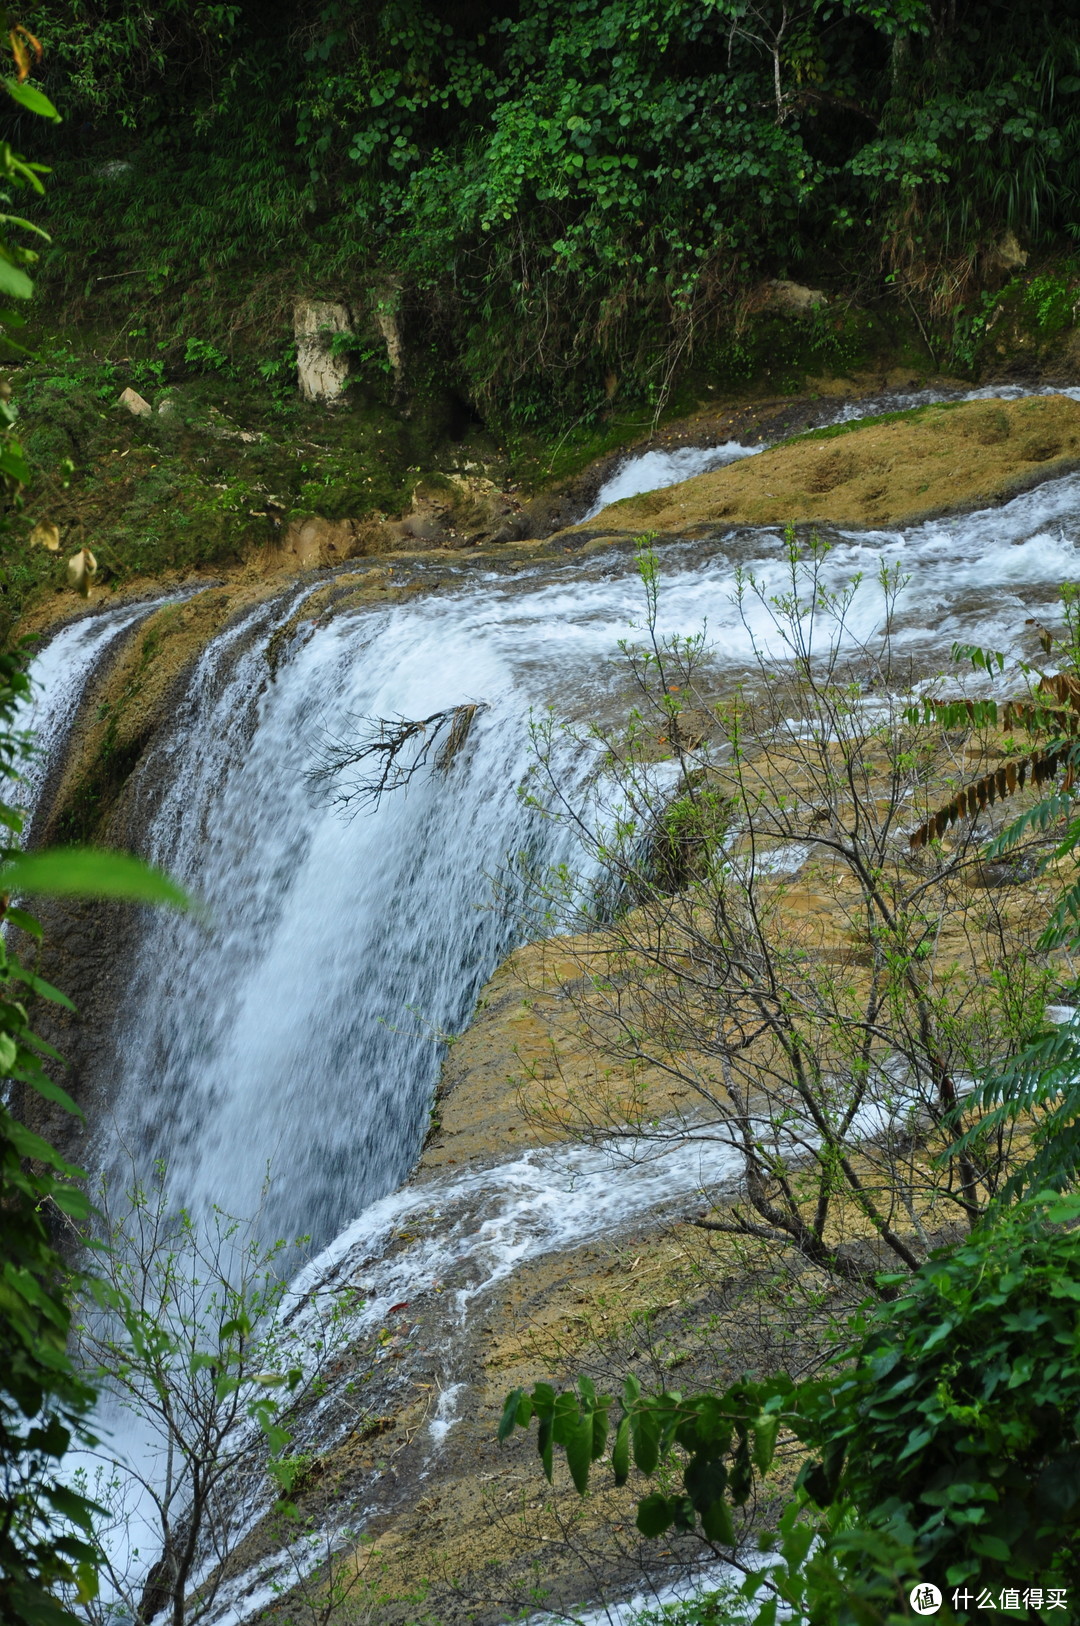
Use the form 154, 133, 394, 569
86, 461, 1080, 1242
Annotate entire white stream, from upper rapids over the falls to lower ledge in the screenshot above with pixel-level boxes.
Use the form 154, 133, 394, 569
26, 392, 1080, 1619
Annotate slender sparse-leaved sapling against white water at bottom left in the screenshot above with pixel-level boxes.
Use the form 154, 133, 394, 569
78, 1164, 346, 1619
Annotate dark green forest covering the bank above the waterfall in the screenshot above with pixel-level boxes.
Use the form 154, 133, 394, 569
15, 0, 1080, 423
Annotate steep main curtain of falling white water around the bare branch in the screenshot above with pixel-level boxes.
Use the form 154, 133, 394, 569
102, 592, 598, 1241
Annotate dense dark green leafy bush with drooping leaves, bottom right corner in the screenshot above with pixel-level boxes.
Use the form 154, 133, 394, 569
499, 1195, 1080, 1626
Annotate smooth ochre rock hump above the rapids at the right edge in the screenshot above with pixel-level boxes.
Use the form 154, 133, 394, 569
556, 395, 1080, 537
